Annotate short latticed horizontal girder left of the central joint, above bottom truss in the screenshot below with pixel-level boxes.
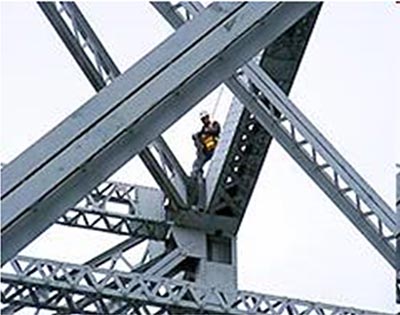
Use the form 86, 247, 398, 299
56, 182, 173, 240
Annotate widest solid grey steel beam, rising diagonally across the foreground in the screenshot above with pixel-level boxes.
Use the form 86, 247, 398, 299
2, 3, 316, 263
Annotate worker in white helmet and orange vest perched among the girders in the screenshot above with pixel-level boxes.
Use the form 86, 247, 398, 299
191, 111, 221, 178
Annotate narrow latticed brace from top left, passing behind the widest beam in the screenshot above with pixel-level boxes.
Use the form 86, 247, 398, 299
33, 2, 187, 208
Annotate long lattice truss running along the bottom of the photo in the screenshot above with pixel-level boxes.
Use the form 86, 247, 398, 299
1, 257, 385, 315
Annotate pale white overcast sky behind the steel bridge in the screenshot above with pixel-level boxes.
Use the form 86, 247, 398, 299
0, 1, 400, 312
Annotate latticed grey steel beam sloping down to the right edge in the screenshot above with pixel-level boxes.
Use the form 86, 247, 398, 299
228, 62, 396, 267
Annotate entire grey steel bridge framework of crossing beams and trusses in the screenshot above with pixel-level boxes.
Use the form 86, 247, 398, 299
1, 2, 399, 315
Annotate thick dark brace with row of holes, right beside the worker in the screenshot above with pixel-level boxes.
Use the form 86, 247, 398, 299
152, 2, 321, 230
